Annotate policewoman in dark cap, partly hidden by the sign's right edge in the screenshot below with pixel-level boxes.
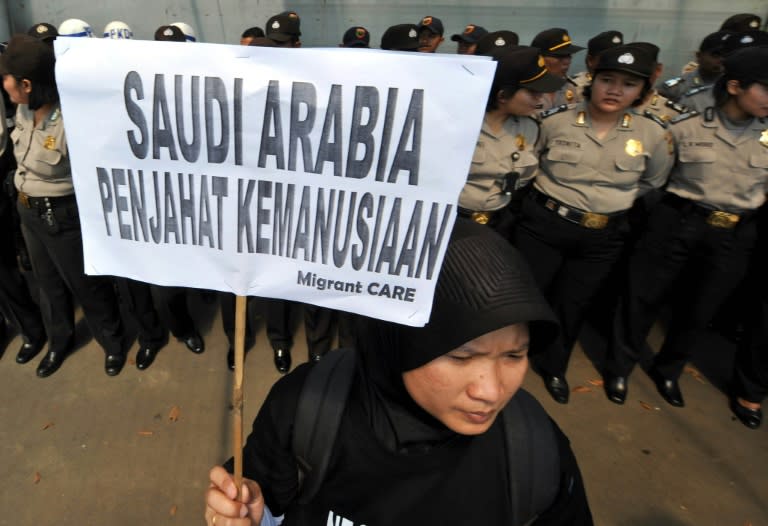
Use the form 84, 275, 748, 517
459, 46, 565, 239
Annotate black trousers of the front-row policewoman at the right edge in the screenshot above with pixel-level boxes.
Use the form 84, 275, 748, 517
606, 198, 756, 379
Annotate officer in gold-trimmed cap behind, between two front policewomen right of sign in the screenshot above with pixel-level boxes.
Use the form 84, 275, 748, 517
531, 27, 584, 110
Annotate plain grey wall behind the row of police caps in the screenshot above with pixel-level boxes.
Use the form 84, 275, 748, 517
0, 0, 768, 74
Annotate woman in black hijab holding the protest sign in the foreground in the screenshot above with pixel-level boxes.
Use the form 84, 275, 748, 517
205, 218, 592, 526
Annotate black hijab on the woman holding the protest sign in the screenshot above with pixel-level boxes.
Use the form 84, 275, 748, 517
353, 218, 558, 453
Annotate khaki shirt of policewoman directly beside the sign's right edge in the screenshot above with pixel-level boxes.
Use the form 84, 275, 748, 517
459, 117, 539, 212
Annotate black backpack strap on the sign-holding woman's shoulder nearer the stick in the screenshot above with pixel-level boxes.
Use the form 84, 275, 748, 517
293, 349, 355, 504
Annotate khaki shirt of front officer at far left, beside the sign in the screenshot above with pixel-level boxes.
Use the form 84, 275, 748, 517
11, 104, 75, 197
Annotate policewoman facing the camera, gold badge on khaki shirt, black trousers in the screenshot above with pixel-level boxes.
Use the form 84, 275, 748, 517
515, 46, 673, 403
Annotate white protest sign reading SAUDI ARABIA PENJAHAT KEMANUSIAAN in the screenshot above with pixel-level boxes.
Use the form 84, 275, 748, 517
56, 38, 495, 326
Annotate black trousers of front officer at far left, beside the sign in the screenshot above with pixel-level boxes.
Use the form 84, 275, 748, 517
17, 200, 125, 354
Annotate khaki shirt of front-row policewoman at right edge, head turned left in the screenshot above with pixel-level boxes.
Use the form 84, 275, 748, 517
667, 111, 768, 214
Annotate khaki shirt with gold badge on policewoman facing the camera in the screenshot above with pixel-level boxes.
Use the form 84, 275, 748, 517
533, 102, 674, 214
